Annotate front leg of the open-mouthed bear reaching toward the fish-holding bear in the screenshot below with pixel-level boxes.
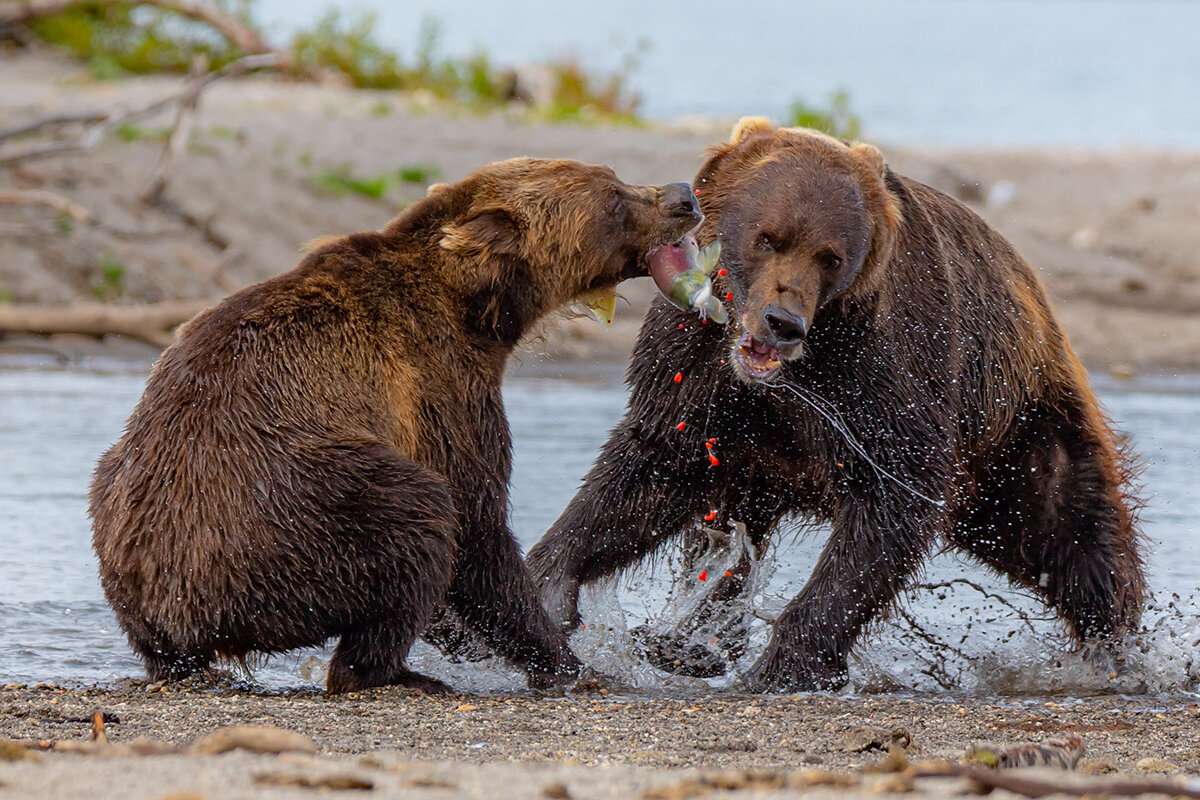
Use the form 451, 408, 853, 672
528, 413, 724, 630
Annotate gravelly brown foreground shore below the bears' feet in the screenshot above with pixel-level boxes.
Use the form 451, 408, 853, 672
0, 682, 1200, 800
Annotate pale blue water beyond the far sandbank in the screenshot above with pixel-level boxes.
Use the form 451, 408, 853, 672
254, 0, 1200, 148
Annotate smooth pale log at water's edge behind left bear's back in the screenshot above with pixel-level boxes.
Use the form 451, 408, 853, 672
0, 300, 215, 347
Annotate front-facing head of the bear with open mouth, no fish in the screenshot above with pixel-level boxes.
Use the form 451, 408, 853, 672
696, 118, 900, 383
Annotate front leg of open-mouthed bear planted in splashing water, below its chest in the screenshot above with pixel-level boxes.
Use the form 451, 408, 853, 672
745, 486, 946, 692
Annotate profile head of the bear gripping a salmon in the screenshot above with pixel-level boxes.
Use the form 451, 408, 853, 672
426, 158, 701, 342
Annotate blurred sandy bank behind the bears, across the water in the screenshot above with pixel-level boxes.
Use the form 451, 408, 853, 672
0, 55, 1200, 374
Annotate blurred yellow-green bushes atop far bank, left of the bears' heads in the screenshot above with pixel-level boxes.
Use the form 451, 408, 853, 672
21, 0, 640, 122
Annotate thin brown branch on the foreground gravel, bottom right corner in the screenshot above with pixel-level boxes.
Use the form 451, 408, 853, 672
912, 762, 1200, 798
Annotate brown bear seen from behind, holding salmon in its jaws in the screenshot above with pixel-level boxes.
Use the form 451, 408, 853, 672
90, 158, 700, 692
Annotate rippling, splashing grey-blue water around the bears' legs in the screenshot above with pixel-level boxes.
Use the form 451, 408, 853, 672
0, 359, 1200, 696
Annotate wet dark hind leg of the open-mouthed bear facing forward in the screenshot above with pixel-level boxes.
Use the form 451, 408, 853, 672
952, 404, 1145, 640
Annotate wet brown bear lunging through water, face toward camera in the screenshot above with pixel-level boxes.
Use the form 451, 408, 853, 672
528, 118, 1145, 691
